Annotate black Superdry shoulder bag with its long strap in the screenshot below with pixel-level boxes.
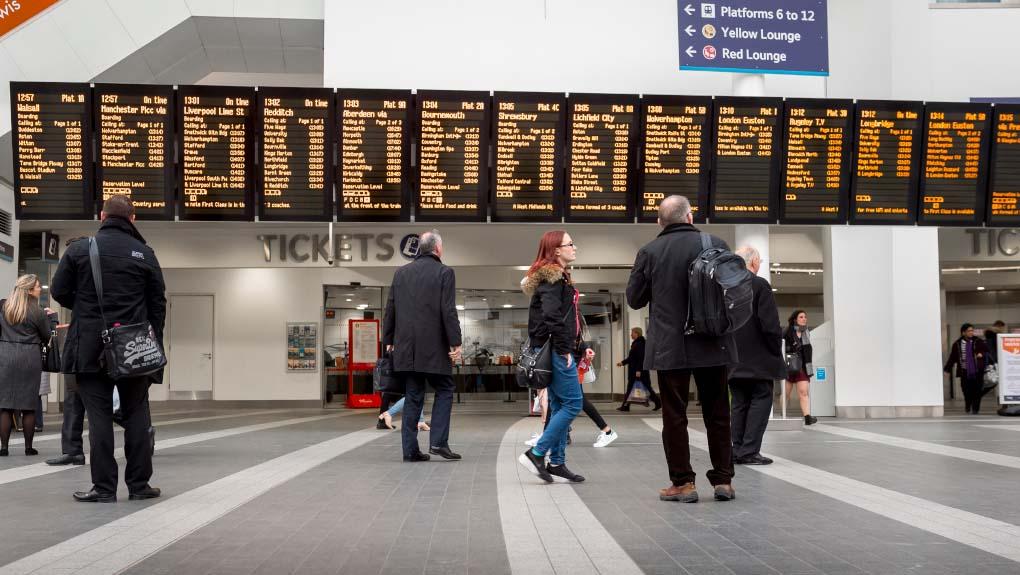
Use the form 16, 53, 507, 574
89, 238, 166, 379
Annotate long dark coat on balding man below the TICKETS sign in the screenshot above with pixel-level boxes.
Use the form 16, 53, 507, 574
383, 254, 461, 375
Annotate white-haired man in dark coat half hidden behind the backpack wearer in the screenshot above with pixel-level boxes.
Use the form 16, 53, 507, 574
729, 246, 786, 465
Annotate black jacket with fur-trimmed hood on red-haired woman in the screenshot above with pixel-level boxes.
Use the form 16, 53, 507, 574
520, 264, 580, 356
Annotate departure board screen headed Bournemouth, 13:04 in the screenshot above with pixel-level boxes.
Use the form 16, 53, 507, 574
414, 91, 490, 221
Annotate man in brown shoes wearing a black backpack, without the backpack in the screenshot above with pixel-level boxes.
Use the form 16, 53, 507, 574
627, 196, 736, 503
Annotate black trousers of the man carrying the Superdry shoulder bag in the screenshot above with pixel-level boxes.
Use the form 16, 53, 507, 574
78, 373, 152, 493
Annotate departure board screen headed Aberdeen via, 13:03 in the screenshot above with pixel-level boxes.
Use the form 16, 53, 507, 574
337, 90, 413, 221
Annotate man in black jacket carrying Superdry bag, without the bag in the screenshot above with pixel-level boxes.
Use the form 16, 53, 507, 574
50, 196, 166, 503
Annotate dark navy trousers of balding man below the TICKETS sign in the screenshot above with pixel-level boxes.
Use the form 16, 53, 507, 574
397, 371, 454, 458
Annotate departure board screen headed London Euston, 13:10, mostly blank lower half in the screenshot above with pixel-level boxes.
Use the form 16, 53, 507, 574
709, 98, 782, 223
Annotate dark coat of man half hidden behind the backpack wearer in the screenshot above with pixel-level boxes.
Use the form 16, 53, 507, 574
729, 275, 786, 379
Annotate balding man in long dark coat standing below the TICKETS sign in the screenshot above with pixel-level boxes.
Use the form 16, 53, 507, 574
383, 229, 461, 461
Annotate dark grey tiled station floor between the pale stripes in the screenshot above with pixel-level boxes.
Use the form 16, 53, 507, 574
0, 402, 1020, 575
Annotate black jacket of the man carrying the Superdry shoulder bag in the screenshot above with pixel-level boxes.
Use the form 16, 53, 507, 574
50, 217, 166, 382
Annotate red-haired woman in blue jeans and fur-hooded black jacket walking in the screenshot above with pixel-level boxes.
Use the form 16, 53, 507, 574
518, 230, 595, 483
